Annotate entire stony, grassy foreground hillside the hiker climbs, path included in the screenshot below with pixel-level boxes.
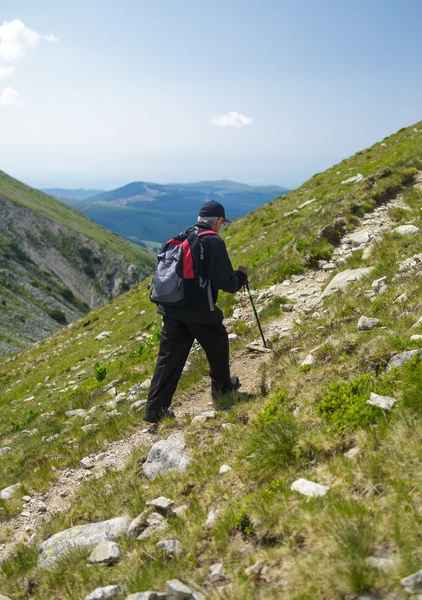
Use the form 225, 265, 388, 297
0, 123, 422, 600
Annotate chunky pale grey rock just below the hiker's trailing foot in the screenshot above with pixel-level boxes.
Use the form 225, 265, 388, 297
142, 433, 190, 479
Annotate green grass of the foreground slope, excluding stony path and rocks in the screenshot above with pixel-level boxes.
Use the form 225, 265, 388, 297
0, 124, 422, 600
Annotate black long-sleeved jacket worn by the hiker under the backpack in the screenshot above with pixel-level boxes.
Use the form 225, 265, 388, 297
158, 223, 247, 324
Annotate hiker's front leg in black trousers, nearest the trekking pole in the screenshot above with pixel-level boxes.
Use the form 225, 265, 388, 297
186, 322, 233, 393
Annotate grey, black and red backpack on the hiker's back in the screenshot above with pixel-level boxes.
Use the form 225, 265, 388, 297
150, 227, 218, 310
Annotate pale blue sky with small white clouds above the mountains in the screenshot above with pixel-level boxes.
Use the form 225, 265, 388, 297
0, 0, 422, 189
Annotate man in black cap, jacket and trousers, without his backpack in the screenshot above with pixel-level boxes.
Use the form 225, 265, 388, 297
143, 200, 248, 423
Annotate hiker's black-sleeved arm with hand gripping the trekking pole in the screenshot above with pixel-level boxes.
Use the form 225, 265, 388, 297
207, 236, 247, 294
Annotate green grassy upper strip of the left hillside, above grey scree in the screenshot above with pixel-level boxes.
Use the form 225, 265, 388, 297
0, 171, 152, 264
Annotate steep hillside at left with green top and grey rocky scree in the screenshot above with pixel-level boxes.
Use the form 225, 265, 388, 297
0, 172, 154, 354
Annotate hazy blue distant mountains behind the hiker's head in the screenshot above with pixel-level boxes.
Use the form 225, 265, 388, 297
52, 180, 288, 245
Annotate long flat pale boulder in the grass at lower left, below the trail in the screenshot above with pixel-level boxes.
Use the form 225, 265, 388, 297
38, 516, 131, 568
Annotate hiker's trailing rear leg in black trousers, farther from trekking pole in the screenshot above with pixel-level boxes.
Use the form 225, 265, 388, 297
143, 317, 194, 423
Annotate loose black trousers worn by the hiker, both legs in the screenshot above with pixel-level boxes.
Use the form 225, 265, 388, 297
144, 317, 230, 422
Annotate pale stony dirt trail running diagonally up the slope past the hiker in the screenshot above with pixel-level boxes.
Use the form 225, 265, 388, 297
0, 186, 410, 563
